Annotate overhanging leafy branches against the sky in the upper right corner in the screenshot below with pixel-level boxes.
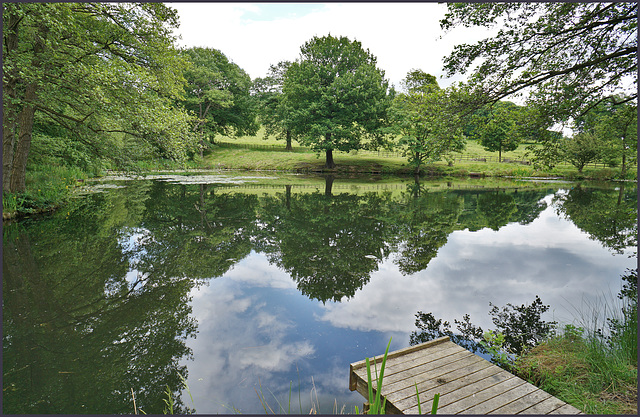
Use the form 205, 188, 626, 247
440, 2, 638, 124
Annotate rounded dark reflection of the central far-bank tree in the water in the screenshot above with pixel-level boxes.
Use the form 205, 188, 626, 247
256, 180, 393, 302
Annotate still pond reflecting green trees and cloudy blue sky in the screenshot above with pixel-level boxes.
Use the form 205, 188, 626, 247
3, 172, 637, 414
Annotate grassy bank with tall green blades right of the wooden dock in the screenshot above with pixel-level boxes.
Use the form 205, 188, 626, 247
516, 270, 638, 414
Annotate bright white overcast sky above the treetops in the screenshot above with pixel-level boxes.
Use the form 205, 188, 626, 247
168, 2, 496, 87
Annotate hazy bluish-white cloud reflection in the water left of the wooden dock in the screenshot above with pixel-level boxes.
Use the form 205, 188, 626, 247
183, 277, 315, 413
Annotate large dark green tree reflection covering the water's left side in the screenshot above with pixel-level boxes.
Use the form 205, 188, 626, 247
3, 187, 197, 414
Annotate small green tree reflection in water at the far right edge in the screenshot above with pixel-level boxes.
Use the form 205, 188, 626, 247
554, 182, 638, 253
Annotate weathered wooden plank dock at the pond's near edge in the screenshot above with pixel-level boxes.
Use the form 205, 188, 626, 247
349, 337, 583, 414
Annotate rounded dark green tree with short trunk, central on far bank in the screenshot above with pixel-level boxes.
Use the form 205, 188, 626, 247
283, 35, 391, 168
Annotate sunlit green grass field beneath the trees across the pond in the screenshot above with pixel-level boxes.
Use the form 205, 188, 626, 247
202, 129, 636, 180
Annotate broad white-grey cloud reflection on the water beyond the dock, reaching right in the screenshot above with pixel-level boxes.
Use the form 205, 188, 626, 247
318, 202, 632, 333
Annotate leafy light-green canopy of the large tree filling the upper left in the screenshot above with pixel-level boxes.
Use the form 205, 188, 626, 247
2, 3, 193, 192
